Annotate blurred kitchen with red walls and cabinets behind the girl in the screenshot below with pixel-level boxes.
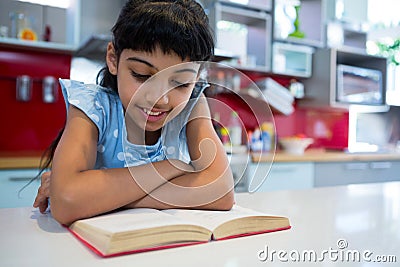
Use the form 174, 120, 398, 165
0, 0, 400, 205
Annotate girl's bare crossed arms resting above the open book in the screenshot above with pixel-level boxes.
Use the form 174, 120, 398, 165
34, 98, 233, 224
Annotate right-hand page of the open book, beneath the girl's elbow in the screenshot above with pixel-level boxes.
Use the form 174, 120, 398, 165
162, 205, 268, 231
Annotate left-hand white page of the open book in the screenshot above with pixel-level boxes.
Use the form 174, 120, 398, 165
71, 208, 200, 233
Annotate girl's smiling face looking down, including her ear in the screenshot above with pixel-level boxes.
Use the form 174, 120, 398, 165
107, 45, 200, 136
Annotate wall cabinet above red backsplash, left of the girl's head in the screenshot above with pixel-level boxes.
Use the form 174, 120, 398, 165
0, 0, 125, 59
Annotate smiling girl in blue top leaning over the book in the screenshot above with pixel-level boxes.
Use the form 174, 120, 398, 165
33, 0, 233, 225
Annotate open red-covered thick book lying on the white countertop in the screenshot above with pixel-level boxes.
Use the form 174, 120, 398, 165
68, 205, 290, 257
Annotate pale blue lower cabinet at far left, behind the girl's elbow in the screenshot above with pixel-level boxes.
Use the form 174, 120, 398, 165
0, 169, 40, 208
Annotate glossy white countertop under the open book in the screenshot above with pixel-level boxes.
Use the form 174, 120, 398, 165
0, 182, 400, 267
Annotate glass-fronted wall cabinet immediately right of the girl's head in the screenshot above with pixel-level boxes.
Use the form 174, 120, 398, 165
205, 1, 272, 73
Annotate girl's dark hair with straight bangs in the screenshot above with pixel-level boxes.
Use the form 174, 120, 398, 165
35, 0, 214, 178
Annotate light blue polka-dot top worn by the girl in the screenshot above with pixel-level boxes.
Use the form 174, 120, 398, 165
60, 79, 208, 169
